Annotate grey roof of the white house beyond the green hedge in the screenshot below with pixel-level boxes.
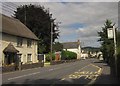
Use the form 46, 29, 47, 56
62, 42, 79, 49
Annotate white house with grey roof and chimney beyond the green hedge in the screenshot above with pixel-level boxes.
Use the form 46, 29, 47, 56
62, 40, 81, 59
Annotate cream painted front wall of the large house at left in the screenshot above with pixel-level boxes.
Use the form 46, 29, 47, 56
2, 34, 38, 64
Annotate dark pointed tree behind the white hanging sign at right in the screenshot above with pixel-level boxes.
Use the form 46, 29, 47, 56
98, 20, 115, 63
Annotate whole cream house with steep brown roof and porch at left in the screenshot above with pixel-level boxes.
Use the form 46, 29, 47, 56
0, 14, 39, 66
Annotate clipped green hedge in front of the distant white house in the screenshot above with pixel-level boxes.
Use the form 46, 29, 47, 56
61, 51, 77, 60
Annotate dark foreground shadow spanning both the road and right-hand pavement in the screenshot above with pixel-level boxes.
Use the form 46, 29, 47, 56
2, 74, 118, 86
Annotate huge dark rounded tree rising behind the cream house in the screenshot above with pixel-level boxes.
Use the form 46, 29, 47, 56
14, 4, 59, 53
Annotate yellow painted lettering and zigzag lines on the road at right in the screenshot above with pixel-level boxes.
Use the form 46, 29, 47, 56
59, 64, 103, 86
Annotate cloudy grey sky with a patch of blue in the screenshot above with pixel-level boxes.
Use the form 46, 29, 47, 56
0, 0, 118, 47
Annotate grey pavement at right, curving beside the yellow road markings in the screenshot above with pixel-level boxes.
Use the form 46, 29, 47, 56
93, 60, 120, 85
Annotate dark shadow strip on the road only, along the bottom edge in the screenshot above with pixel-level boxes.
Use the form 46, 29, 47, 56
2, 77, 91, 86
